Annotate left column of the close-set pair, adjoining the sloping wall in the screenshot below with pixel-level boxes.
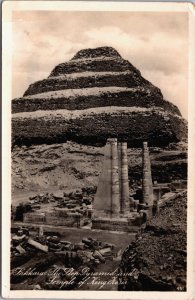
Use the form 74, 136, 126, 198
111, 139, 120, 217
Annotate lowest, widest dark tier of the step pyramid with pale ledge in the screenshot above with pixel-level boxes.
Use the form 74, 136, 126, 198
12, 107, 187, 146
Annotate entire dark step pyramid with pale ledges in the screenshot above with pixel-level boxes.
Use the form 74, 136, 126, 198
12, 47, 187, 146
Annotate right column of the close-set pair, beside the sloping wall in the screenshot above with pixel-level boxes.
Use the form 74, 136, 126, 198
121, 142, 130, 214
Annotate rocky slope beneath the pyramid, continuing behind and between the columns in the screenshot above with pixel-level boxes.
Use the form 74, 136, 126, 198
12, 142, 187, 196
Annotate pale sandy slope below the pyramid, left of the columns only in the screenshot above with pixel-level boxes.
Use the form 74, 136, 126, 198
12, 142, 103, 196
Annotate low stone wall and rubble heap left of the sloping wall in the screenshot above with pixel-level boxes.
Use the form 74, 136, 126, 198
12, 186, 96, 227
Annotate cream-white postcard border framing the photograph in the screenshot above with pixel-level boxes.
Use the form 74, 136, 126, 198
2, 1, 195, 300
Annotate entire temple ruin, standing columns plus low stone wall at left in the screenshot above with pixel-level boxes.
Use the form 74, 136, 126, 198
20, 138, 157, 232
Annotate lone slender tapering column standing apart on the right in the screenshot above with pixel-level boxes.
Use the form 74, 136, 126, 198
142, 142, 153, 206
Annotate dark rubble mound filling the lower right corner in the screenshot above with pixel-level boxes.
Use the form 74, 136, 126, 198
119, 192, 187, 291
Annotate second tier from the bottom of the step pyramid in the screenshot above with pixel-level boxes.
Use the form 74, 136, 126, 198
12, 87, 180, 115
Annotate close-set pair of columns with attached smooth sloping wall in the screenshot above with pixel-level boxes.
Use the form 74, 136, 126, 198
94, 139, 129, 218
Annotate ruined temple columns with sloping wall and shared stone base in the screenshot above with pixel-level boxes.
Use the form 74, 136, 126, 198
92, 138, 154, 232
